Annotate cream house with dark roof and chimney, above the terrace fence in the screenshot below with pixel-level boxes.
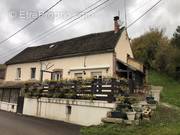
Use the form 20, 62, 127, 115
5, 16, 144, 87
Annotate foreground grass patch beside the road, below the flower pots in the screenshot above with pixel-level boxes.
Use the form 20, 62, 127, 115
81, 106, 180, 135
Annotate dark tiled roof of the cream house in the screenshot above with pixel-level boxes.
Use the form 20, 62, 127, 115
6, 28, 124, 65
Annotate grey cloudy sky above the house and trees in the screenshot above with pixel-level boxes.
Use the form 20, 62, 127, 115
0, 0, 180, 63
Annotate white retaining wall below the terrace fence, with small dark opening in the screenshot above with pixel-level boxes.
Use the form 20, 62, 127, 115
23, 98, 115, 126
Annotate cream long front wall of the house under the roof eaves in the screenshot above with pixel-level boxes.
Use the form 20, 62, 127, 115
5, 53, 113, 81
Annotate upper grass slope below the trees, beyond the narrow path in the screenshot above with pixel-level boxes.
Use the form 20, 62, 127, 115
148, 71, 180, 107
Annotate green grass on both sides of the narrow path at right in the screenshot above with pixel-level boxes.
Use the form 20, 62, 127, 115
81, 71, 180, 135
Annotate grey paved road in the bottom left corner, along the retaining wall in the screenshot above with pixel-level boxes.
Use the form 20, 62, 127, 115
0, 111, 80, 135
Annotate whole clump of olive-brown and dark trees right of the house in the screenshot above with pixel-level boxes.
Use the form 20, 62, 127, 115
132, 26, 180, 77
